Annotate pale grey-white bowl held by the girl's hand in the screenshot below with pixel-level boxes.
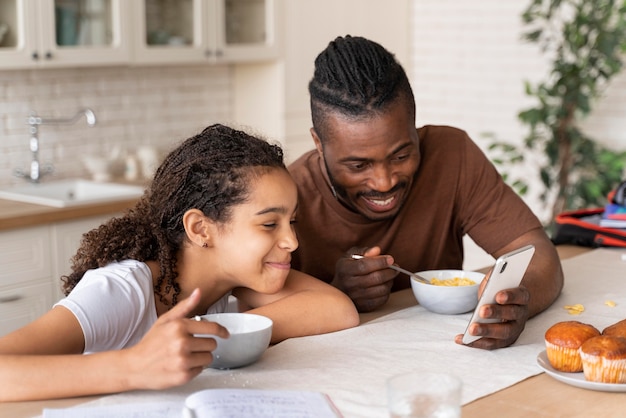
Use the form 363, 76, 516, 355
197, 313, 273, 369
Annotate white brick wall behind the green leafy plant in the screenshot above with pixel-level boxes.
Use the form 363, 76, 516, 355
411, 0, 626, 268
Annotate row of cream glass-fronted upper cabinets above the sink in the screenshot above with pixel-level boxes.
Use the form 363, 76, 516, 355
0, 0, 281, 69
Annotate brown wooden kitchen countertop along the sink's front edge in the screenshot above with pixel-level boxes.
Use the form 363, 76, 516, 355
0, 199, 138, 231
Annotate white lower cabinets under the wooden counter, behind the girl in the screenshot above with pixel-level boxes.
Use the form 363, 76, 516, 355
0, 215, 113, 336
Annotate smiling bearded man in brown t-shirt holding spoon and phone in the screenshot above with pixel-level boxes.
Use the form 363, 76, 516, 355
290, 36, 563, 349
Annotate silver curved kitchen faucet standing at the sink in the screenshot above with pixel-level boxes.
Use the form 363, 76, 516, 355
15, 108, 96, 183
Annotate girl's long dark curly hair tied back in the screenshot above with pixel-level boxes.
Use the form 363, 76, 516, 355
62, 125, 286, 306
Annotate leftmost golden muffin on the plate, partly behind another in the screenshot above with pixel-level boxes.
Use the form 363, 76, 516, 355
545, 321, 600, 373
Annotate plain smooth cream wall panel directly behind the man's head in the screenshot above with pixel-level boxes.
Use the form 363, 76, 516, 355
284, 0, 411, 160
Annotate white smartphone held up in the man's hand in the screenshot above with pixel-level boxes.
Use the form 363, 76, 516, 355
463, 245, 535, 344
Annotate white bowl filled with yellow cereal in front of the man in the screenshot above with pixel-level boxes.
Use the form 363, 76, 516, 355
411, 270, 485, 315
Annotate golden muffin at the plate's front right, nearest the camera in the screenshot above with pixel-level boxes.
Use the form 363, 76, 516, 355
580, 335, 626, 383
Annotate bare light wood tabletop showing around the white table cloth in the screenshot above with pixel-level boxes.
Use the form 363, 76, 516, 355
0, 246, 626, 418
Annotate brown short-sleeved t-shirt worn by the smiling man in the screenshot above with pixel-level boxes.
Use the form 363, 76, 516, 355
289, 126, 542, 290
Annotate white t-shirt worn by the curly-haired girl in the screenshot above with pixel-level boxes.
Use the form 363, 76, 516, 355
55, 260, 230, 353
